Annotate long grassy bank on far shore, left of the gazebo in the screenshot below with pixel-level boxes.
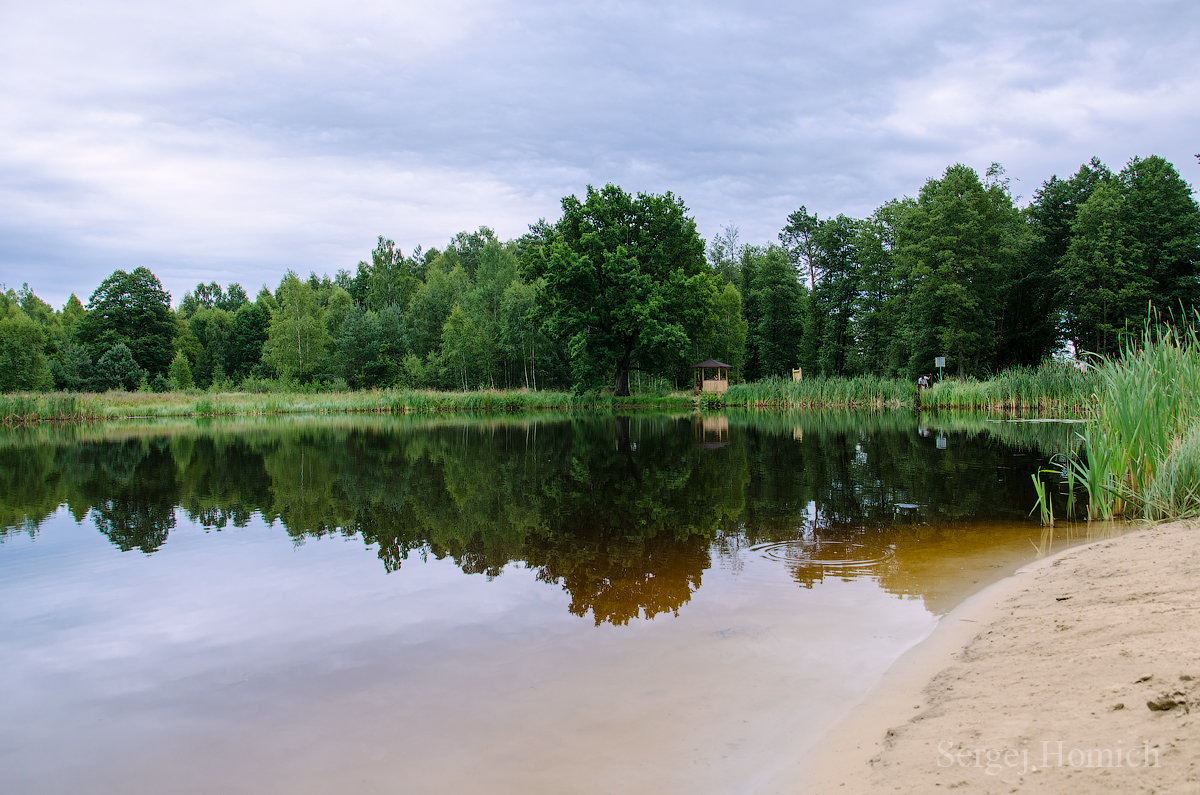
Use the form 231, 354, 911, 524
0, 389, 692, 425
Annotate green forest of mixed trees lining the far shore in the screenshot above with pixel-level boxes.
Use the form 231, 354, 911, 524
0, 156, 1200, 395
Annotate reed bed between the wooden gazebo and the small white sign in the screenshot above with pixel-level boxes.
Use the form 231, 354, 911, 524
701, 376, 917, 408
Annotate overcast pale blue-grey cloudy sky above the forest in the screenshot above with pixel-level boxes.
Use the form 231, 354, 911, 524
0, 0, 1200, 306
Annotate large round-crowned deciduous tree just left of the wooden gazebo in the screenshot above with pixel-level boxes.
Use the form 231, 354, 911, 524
526, 185, 719, 395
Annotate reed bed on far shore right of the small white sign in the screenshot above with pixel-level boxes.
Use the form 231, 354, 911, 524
920, 360, 1099, 413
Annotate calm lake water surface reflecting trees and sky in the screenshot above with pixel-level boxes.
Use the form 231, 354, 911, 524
0, 413, 1104, 793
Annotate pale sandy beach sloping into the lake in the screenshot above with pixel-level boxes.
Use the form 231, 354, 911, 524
806, 524, 1200, 793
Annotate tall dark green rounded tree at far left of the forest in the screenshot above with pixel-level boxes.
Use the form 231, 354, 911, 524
78, 268, 175, 375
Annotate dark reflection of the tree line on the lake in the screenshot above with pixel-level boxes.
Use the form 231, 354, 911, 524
0, 413, 1070, 623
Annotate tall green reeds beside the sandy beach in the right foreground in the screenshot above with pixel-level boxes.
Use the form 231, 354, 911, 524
1070, 317, 1200, 520
